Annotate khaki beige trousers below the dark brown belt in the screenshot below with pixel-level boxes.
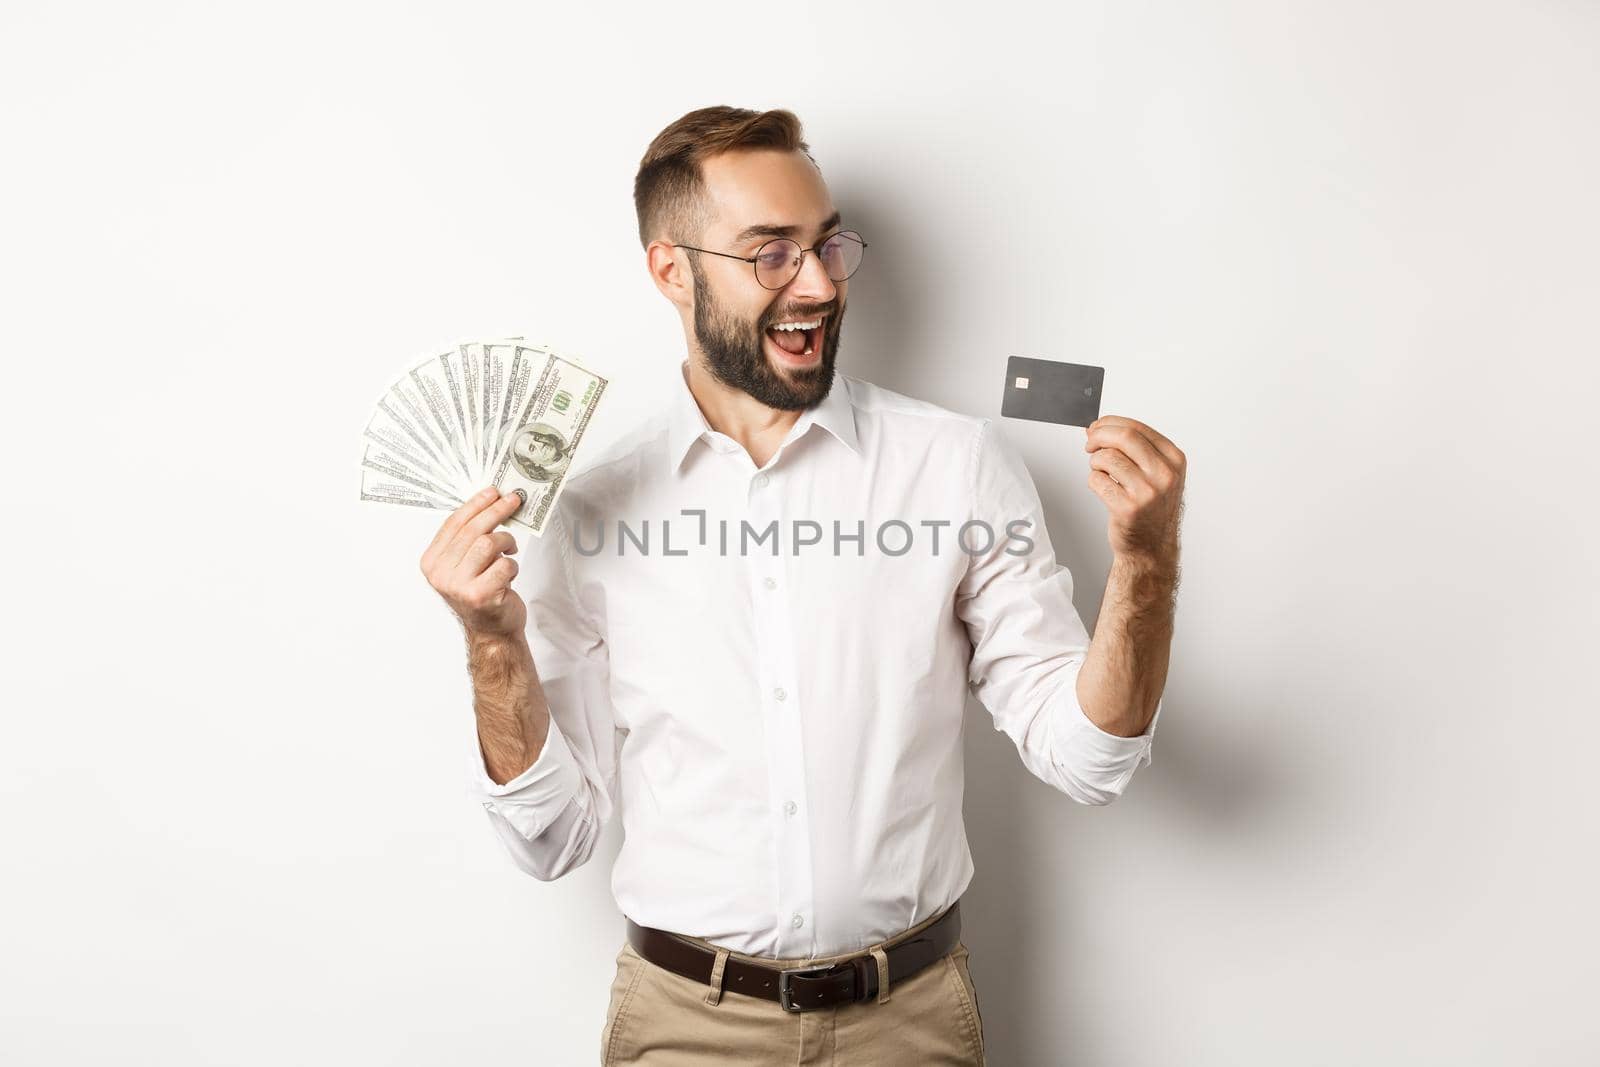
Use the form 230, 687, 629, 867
600, 915, 984, 1067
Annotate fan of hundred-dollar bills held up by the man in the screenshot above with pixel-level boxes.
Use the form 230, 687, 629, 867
362, 338, 606, 536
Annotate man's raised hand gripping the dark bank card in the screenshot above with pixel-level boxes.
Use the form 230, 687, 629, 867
1083, 414, 1187, 566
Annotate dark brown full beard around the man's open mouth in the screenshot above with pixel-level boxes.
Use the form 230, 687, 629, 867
694, 269, 845, 411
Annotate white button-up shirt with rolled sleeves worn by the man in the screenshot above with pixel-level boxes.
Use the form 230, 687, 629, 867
469, 363, 1160, 957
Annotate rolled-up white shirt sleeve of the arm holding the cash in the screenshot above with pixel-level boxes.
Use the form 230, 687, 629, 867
469, 494, 616, 881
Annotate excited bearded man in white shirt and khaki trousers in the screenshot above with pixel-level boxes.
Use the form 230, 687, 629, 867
422, 107, 1186, 1064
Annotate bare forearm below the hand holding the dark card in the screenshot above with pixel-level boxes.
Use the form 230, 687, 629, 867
1077, 557, 1178, 737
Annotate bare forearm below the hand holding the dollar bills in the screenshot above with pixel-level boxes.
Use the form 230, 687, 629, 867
467, 632, 550, 785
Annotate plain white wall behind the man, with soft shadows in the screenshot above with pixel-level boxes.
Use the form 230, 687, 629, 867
0, 0, 1600, 1067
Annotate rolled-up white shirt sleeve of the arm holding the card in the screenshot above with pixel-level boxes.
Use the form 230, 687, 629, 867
955, 419, 1162, 805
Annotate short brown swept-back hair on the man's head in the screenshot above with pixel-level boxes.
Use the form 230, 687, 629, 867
634, 106, 816, 251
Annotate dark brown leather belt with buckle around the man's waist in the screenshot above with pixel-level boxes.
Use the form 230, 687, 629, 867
627, 901, 962, 1011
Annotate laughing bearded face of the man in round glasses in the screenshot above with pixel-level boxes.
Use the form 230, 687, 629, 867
690, 149, 848, 411
